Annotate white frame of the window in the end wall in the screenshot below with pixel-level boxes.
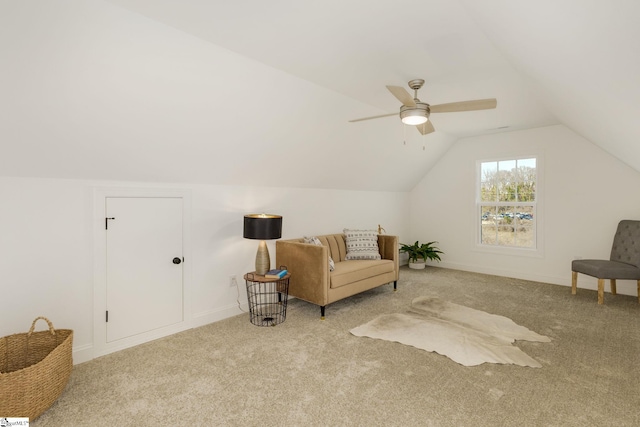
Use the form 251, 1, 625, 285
473, 153, 544, 257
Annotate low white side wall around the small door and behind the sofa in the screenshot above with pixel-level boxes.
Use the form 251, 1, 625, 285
0, 177, 409, 362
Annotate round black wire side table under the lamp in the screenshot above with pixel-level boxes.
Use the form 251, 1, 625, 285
244, 272, 291, 326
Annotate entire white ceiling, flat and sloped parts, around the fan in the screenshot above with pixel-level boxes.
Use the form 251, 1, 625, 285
0, 0, 640, 191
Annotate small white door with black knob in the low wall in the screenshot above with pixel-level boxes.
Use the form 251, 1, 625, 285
105, 197, 183, 343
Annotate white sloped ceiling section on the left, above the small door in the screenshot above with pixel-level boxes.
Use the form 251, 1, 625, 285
0, 0, 453, 191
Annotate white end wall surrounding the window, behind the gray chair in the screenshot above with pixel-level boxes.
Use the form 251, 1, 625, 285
410, 125, 640, 295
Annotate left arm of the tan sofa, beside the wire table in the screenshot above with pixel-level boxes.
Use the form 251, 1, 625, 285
276, 240, 330, 306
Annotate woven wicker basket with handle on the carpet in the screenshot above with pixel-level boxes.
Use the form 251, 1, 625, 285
0, 317, 73, 420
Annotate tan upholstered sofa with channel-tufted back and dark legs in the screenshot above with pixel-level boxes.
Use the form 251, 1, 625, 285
276, 234, 399, 319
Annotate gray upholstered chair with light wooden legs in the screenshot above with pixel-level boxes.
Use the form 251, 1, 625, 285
571, 219, 640, 304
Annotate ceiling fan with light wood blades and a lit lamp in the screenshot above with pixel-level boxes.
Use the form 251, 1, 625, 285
349, 79, 498, 135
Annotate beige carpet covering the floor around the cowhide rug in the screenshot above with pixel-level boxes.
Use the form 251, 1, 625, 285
31, 267, 640, 427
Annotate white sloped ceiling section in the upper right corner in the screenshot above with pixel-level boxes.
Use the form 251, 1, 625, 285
463, 0, 640, 171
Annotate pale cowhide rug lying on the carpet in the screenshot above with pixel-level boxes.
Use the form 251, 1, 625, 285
350, 297, 551, 368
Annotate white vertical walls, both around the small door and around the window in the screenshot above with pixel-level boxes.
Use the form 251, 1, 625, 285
0, 126, 640, 362
